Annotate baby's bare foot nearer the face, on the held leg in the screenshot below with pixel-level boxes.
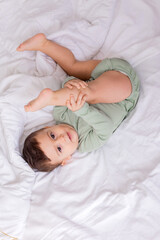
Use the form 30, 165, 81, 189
24, 88, 54, 112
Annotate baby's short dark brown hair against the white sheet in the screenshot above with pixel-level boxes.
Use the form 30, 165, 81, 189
23, 128, 60, 172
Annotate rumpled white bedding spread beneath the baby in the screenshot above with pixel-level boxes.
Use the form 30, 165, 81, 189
0, 0, 160, 240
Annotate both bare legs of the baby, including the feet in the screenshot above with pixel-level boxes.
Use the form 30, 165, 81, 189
17, 33, 132, 111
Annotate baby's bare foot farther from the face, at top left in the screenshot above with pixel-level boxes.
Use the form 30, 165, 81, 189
16, 33, 47, 52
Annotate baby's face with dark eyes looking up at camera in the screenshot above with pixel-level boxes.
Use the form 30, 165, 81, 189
36, 124, 78, 163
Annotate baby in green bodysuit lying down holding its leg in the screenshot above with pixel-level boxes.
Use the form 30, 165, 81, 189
17, 33, 139, 171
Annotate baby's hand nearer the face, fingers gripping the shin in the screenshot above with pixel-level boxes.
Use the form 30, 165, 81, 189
66, 92, 86, 112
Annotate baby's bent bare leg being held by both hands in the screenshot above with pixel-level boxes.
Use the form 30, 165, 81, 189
25, 71, 132, 112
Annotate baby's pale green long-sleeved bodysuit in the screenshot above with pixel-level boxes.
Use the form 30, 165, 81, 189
53, 58, 139, 152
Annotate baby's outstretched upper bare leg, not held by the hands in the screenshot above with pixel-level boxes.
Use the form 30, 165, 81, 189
17, 33, 100, 80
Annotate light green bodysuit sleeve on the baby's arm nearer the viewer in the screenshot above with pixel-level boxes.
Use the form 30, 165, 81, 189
74, 103, 114, 152
